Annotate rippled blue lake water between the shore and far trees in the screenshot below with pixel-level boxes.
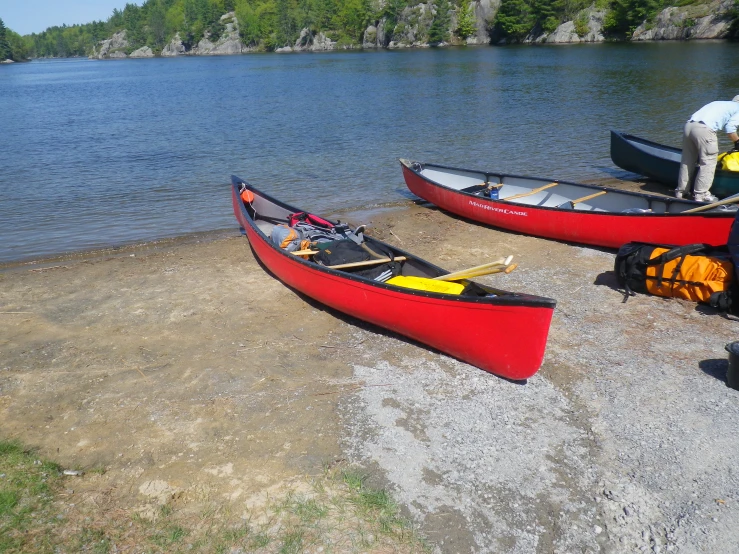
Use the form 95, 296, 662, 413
0, 42, 739, 262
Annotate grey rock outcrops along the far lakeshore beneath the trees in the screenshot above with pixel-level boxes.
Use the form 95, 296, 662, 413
89, 0, 734, 59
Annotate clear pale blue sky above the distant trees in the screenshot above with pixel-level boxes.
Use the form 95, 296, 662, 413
0, 0, 143, 35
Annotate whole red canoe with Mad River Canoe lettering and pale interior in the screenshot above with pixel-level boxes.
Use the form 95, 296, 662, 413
400, 160, 736, 248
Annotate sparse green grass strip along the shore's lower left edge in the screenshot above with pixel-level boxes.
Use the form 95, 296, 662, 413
0, 441, 429, 554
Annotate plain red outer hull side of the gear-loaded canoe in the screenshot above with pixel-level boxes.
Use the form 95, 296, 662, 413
232, 183, 554, 380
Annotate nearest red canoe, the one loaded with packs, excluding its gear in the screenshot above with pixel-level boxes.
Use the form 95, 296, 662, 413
231, 176, 556, 380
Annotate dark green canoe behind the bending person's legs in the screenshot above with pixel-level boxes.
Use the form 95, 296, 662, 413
611, 131, 739, 198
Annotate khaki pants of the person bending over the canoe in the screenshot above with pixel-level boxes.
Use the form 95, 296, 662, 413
677, 121, 718, 195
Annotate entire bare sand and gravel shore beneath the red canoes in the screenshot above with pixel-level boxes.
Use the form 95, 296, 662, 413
0, 192, 739, 553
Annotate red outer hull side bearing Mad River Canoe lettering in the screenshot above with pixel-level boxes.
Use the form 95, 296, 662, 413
401, 162, 734, 248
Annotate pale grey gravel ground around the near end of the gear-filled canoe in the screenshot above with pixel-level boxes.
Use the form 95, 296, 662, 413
341, 212, 739, 553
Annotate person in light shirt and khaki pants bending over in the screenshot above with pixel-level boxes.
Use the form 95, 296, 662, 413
675, 95, 739, 202
